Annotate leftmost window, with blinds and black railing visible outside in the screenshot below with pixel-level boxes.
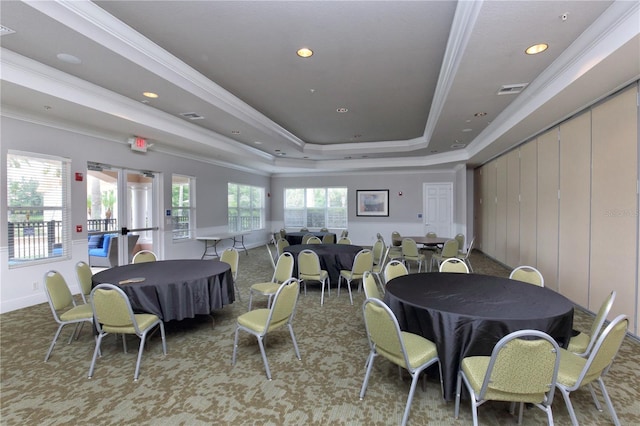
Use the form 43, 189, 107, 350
7, 151, 71, 266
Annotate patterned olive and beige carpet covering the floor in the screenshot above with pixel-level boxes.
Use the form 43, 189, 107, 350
0, 247, 640, 425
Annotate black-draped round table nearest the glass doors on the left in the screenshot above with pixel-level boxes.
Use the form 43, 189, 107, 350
92, 259, 235, 322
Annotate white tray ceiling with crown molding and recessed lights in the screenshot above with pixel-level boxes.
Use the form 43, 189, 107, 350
0, 0, 640, 173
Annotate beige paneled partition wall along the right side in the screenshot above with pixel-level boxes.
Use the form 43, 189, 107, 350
475, 84, 640, 335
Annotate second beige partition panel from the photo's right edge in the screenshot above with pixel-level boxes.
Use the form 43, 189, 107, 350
558, 112, 591, 306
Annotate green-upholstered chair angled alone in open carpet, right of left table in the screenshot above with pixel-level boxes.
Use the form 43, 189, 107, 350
231, 278, 302, 380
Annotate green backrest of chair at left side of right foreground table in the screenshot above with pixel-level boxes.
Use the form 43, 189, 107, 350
362, 298, 410, 368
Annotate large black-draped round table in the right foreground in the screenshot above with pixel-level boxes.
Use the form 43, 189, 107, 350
385, 272, 574, 401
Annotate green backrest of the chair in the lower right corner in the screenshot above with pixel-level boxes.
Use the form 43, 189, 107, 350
575, 315, 629, 388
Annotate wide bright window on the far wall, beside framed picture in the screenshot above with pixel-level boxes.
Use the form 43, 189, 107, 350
284, 188, 349, 229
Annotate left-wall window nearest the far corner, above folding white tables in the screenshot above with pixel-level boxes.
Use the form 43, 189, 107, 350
227, 183, 264, 232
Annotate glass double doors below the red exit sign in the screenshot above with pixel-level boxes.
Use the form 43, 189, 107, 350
87, 163, 158, 268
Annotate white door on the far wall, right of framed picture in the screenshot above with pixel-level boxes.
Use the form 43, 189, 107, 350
423, 182, 453, 238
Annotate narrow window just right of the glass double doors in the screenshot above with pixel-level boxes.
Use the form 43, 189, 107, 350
171, 175, 196, 240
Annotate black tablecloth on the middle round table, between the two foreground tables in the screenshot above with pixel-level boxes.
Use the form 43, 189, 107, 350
284, 244, 362, 284
